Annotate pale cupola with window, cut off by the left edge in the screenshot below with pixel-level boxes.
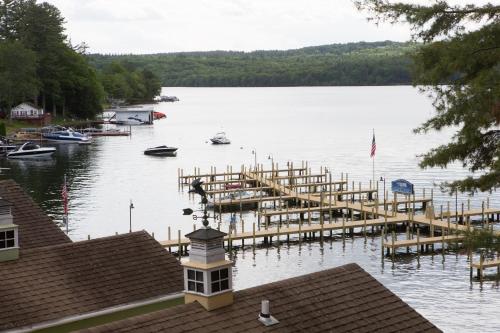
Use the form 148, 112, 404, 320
0, 198, 19, 261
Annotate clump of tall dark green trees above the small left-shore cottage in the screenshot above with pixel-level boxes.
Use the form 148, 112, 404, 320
0, 0, 103, 118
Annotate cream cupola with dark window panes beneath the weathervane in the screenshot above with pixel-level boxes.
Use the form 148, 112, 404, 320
183, 227, 233, 311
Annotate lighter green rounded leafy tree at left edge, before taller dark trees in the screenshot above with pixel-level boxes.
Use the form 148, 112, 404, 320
0, 42, 39, 111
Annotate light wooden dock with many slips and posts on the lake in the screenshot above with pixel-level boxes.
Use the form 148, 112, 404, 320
169, 162, 500, 269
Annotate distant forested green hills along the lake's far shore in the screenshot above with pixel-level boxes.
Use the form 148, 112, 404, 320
90, 41, 418, 87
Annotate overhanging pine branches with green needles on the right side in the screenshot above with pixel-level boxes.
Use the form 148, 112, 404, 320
356, 0, 500, 192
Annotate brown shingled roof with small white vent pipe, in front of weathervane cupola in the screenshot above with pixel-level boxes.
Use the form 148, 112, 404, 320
80, 264, 441, 333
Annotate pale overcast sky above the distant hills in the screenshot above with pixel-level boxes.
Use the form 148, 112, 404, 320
42, 0, 468, 53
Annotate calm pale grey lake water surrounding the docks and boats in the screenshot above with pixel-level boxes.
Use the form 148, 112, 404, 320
1, 87, 500, 332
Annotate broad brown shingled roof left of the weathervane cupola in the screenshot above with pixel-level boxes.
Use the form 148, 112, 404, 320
0, 231, 183, 331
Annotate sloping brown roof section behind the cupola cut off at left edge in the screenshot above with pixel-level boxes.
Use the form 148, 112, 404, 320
0, 180, 71, 249
